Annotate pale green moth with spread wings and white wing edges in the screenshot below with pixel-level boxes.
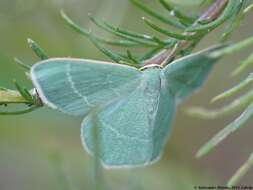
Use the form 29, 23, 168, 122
31, 46, 222, 168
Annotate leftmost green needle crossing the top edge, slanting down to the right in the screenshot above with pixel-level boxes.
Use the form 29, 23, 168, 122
130, 0, 185, 29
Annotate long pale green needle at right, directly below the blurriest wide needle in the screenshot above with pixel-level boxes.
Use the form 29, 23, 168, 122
197, 102, 253, 158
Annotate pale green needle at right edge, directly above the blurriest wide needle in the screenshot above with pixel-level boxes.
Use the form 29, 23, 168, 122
212, 73, 253, 102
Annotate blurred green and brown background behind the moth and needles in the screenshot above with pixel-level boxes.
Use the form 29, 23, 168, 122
0, 0, 253, 190
